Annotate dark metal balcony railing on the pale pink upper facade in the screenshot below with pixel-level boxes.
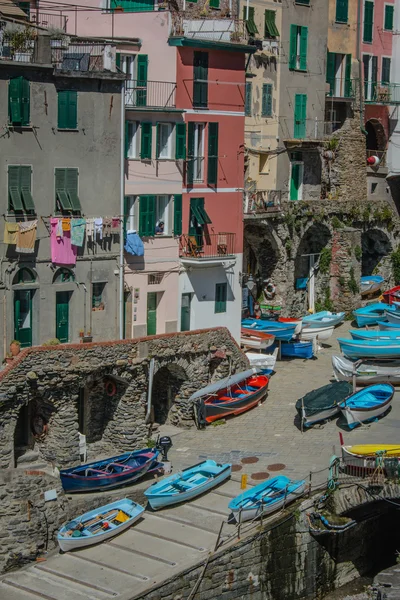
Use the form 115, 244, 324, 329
125, 79, 176, 108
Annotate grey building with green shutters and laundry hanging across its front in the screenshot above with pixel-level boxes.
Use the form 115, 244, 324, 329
0, 36, 124, 358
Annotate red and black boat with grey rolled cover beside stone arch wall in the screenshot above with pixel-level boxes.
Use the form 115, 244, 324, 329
189, 368, 269, 428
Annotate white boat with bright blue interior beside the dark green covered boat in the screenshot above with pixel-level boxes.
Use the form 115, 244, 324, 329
339, 383, 394, 429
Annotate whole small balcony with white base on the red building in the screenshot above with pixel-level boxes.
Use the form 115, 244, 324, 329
179, 233, 236, 267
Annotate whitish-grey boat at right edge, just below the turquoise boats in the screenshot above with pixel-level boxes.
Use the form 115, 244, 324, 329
332, 356, 400, 386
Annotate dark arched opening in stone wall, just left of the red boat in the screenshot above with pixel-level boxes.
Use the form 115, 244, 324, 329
151, 364, 188, 425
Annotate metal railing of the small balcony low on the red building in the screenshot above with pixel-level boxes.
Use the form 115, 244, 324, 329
179, 233, 236, 260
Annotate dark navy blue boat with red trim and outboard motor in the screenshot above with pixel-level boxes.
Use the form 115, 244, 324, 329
60, 448, 160, 493
